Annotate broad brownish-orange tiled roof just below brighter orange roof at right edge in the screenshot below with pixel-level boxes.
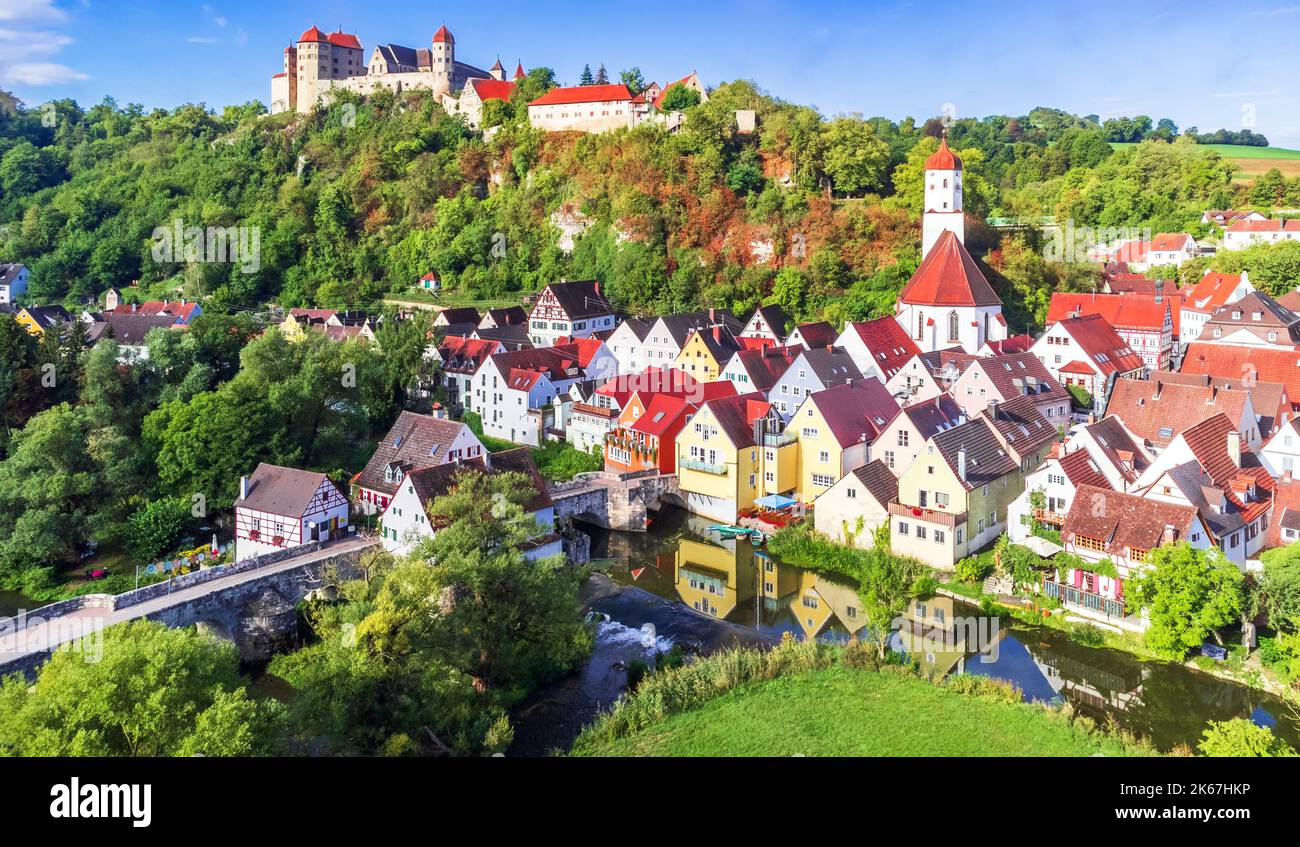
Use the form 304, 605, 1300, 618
1106, 374, 1262, 455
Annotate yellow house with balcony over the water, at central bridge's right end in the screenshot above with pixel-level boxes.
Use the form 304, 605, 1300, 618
677, 394, 781, 524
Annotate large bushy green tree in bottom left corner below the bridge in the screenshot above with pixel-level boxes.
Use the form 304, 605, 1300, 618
0, 621, 282, 756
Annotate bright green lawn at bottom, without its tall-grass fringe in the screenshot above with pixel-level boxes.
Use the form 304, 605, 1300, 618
575, 666, 1143, 756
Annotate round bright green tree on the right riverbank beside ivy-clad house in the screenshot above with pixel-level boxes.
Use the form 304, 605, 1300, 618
1126, 542, 1245, 659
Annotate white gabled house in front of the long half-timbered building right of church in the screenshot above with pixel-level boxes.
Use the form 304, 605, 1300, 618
1032, 314, 1145, 411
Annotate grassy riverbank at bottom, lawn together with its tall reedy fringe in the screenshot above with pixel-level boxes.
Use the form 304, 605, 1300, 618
572, 639, 1153, 756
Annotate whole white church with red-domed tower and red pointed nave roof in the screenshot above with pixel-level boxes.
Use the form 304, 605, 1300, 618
894, 133, 1008, 353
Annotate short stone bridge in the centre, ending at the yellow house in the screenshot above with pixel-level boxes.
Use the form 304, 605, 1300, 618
550, 472, 685, 533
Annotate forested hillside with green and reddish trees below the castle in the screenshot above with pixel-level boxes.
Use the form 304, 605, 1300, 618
0, 81, 1300, 322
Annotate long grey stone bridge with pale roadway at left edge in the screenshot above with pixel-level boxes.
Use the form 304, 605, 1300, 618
0, 537, 377, 677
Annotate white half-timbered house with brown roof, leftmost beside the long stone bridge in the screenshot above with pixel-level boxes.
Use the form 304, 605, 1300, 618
235, 462, 348, 561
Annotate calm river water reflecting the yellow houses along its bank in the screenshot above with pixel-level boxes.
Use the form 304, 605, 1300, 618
593, 511, 1300, 750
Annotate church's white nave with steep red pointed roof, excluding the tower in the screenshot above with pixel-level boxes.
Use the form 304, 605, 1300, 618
894, 230, 1008, 353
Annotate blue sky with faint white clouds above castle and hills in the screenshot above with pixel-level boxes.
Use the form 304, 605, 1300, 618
0, 0, 1300, 148
